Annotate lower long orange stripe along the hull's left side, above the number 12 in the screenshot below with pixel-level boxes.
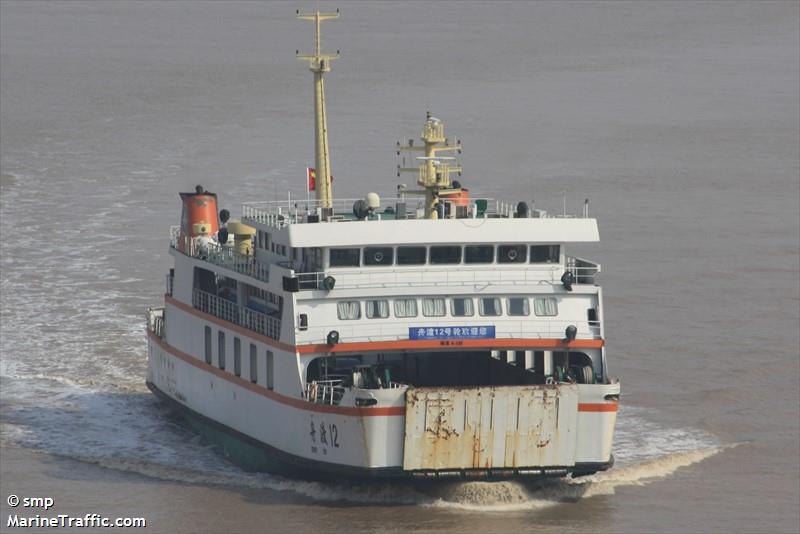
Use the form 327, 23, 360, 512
147, 330, 406, 417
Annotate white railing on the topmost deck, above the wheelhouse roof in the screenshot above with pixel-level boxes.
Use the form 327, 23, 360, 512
242, 196, 588, 228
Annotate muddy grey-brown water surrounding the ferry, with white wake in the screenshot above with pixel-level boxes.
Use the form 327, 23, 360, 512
0, 1, 800, 533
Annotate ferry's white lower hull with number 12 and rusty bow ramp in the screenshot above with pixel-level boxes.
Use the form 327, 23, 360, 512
148, 297, 619, 479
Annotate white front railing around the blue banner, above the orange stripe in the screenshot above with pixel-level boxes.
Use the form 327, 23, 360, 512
296, 317, 601, 344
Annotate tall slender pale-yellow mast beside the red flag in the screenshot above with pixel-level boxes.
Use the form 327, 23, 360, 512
297, 9, 339, 216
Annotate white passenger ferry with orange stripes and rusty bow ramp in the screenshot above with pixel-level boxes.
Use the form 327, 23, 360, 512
147, 11, 620, 480
